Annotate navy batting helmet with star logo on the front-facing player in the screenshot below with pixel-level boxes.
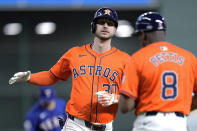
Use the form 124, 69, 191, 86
91, 7, 118, 33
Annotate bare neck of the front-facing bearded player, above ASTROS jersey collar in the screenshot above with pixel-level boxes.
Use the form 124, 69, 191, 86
91, 39, 111, 53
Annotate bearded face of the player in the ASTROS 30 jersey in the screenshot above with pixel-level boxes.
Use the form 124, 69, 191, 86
95, 19, 116, 40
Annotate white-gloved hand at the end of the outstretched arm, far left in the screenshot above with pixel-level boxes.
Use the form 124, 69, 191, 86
9, 71, 31, 84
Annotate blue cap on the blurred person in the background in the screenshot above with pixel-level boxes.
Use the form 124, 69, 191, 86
40, 86, 55, 102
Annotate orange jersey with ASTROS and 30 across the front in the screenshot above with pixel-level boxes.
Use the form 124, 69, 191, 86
50, 44, 129, 124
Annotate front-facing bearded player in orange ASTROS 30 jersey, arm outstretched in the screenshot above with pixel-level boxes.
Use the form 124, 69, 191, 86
9, 8, 129, 131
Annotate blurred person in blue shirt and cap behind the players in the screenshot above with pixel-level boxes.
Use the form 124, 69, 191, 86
23, 86, 67, 131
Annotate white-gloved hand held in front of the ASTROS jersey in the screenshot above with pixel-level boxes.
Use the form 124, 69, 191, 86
96, 91, 118, 107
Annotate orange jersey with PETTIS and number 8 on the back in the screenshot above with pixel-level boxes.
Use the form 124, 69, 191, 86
120, 42, 197, 115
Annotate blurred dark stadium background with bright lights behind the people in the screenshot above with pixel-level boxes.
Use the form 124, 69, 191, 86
0, 0, 197, 131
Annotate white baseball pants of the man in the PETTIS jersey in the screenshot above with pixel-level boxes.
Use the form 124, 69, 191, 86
132, 112, 187, 131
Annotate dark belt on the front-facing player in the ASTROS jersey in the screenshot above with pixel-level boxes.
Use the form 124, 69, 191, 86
68, 114, 106, 131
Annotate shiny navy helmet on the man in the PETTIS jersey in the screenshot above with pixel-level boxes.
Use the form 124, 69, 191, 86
135, 12, 166, 34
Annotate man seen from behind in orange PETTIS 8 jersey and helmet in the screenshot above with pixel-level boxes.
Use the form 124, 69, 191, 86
120, 12, 197, 131
